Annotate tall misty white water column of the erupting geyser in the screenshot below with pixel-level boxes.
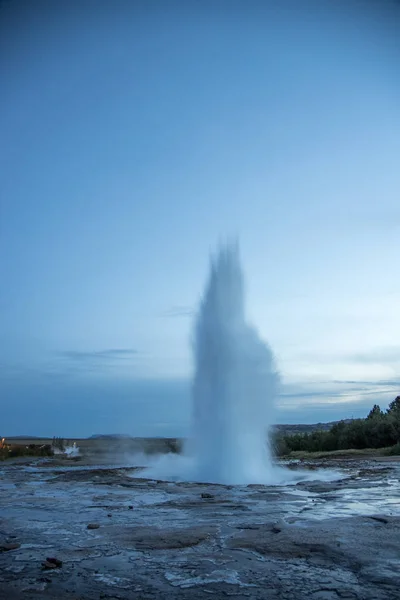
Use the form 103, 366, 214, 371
186, 244, 279, 484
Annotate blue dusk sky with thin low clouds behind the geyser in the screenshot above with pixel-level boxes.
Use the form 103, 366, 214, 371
0, 0, 400, 436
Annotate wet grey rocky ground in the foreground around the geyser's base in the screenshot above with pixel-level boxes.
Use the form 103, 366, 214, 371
0, 460, 400, 600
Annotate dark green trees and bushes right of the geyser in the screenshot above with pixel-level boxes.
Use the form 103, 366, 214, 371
276, 396, 400, 456
